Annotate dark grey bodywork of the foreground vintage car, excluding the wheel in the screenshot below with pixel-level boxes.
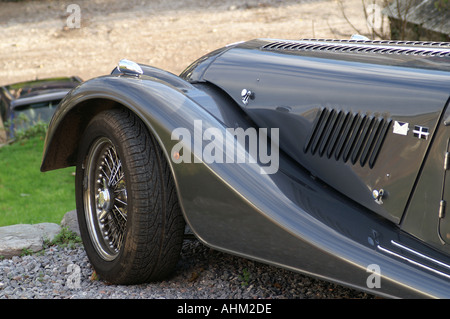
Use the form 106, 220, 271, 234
41, 39, 450, 298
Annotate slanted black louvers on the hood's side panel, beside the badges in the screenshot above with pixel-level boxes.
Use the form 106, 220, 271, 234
304, 108, 391, 168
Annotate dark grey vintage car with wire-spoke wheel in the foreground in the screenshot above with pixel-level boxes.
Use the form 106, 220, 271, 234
41, 38, 450, 298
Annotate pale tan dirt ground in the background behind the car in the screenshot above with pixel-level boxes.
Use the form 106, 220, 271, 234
0, 0, 367, 85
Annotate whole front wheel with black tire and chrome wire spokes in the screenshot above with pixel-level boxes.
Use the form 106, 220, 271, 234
75, 110, 185, 284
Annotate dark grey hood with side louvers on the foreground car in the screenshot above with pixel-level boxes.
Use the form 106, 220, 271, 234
182, 39, 450, 223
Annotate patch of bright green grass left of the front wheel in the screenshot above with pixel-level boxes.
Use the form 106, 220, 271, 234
0, 136, 75, 226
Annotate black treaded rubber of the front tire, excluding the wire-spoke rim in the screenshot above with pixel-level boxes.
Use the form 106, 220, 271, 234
76, 109, 185, 284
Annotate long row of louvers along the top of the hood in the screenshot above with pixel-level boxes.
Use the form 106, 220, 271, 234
261, 39, 450, 57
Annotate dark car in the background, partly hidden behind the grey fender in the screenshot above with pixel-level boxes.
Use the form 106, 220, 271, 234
0, 76, 82, 137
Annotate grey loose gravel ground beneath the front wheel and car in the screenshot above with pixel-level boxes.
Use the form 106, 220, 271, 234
0, 240, 373, 299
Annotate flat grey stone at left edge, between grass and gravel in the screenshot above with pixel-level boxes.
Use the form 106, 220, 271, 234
0, 223, 61, 258
